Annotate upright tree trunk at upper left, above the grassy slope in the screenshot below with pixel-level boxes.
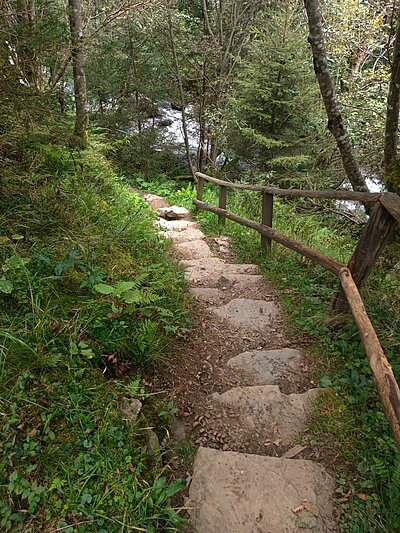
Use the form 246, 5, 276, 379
68, 0, 89, 148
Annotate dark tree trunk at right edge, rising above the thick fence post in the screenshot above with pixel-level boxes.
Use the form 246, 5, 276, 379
384, 9, 400, 193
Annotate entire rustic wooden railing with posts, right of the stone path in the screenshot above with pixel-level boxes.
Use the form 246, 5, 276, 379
193, 172, 400, 447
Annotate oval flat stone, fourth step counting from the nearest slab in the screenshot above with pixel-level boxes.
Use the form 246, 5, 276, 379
209, 298, 279, 330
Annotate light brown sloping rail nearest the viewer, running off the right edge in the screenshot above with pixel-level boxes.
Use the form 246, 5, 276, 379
340, 268, 400, 447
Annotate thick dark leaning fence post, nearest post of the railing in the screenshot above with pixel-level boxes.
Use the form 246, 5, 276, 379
330, 202, 398, 313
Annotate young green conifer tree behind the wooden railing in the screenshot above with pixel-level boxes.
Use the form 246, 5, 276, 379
228, 2, 316, 175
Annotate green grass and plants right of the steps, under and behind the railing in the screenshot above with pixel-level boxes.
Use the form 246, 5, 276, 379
134, 174, 400, 533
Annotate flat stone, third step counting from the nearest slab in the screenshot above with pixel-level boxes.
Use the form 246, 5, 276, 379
227, 348, 301, 385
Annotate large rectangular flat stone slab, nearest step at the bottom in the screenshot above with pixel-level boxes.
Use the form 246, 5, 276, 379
189, 448, 336, 533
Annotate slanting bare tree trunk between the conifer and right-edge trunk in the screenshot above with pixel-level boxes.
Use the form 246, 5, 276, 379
304, 0, 368, 191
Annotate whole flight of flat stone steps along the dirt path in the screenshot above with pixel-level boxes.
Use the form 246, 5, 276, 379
144, 195, 337, 533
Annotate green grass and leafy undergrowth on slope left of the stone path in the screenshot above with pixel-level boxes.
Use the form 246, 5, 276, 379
0, 129, 188, 533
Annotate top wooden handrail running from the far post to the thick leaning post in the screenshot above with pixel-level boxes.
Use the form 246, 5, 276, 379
196, 172, 382, 202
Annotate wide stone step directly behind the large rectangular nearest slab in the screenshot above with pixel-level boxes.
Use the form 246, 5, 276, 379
212, 385, 318, 446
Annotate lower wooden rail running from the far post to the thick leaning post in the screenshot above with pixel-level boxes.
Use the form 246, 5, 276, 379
193, 200, 344, 276
